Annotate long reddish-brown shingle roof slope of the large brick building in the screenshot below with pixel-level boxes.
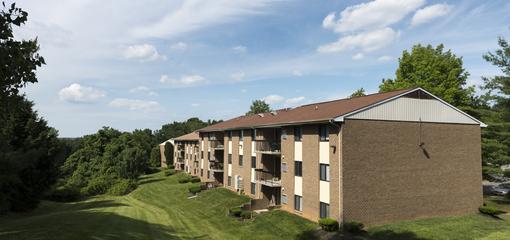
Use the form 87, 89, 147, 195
198, 89, 411, 132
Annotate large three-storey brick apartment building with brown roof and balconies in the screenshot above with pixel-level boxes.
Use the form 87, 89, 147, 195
173, 88, 485, 224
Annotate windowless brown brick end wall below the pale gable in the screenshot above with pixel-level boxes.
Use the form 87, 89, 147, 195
342, 120, 482, 224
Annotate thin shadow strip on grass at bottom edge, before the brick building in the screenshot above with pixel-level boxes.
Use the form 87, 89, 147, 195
296, 230, 428, 240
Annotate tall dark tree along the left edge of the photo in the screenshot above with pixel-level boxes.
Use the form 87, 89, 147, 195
0, 2, 63, 212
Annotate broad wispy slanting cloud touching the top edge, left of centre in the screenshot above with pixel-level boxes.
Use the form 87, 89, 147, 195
132, 0, 272, 38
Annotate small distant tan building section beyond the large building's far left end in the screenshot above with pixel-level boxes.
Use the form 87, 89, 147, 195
174, 132, 202, 175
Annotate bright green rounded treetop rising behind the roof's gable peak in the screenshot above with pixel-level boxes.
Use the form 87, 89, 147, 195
379, 44, 474, 107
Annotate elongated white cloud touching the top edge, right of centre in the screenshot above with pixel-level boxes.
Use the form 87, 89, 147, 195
322, 0, 425, 32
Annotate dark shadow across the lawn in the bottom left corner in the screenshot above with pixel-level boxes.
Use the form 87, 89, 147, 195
0, 201, 187, 240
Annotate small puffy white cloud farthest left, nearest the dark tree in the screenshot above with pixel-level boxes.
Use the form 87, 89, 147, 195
58, 83, 106, 103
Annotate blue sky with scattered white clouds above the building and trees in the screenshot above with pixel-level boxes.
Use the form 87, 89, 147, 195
12, 0, 510, 137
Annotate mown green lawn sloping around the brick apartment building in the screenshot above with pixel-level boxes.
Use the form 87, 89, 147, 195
0, 173, 510, 240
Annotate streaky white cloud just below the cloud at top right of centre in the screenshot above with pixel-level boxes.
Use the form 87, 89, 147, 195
317, 28, 400, 53
